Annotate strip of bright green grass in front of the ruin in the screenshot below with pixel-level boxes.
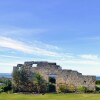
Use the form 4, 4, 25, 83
0, 93, 100, 100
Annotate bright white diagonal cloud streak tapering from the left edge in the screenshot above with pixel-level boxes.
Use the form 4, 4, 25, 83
0, 37, 59, 56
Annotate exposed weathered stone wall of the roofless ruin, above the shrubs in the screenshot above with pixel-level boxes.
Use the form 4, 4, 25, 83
13, 61, 96, 92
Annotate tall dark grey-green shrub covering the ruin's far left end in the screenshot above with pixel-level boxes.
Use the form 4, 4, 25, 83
13, 68, 31, 92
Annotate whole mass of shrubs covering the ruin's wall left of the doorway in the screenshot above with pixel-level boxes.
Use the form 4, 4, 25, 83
13, 68, 47, 93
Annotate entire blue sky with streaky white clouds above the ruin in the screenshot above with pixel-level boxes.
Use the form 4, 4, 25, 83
0, 0, 100, 76
